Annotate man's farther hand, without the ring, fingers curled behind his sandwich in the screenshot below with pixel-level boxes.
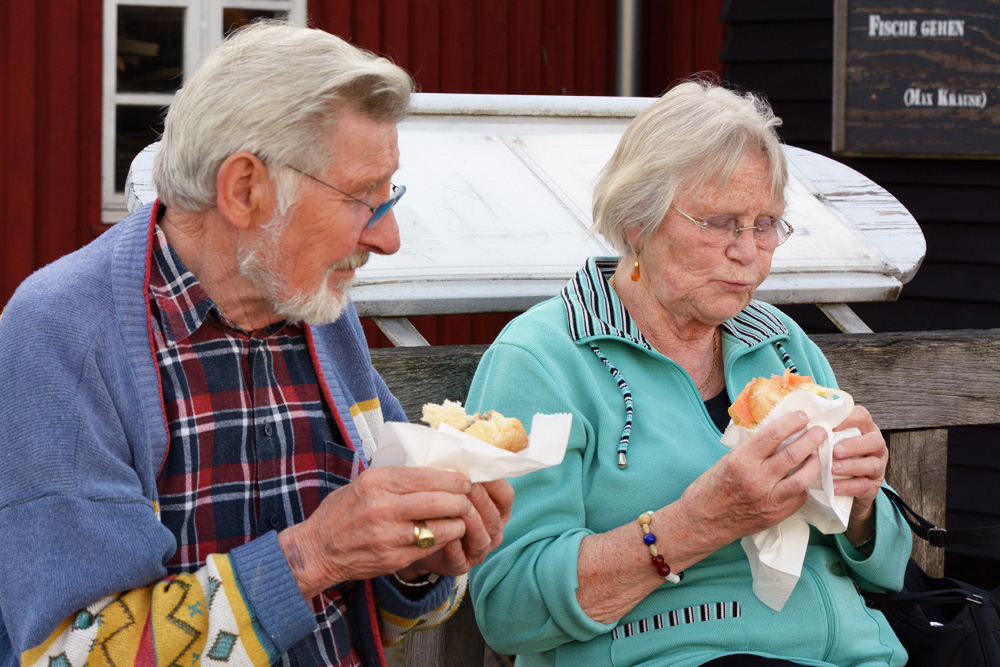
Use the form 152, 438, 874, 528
399, 479, 514, 579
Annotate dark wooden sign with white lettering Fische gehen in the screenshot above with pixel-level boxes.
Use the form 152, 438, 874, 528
833, 0, 1000, 158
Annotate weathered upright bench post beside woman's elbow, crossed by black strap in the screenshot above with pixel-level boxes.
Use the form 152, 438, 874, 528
886, 429, 948, 577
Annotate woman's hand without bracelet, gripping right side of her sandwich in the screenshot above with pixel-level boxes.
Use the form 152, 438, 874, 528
833, 405, 889, 543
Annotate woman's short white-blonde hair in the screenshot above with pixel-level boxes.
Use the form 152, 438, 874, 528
592, 80, 788, 255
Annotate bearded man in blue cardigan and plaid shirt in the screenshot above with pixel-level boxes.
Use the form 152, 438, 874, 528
0, 19, 513, 667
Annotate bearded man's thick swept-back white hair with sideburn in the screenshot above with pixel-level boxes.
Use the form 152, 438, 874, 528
153, 21, 413, 213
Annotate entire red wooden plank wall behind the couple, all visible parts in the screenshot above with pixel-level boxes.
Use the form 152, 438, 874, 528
0, 0, 725, 345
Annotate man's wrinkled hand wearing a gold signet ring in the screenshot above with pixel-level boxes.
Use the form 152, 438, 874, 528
278, 467, 492, 599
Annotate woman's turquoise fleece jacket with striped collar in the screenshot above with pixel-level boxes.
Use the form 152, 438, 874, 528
467, 258, 911, 667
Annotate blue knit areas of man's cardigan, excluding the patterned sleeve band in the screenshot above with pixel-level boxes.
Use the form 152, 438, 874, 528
0, 205, 454, 667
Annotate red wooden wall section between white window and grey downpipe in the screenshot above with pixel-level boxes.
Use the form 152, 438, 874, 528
310, 0, 615, 95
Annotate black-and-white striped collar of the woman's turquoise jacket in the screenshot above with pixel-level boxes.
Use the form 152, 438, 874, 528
559, 257, 788, 350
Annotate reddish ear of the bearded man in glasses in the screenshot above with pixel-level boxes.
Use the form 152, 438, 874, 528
215, 151, 275, 229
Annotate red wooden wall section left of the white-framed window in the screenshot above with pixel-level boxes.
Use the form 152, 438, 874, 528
0, 0, 102, 307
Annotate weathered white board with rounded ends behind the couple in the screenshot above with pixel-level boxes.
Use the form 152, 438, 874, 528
129, 94, 926, 317
